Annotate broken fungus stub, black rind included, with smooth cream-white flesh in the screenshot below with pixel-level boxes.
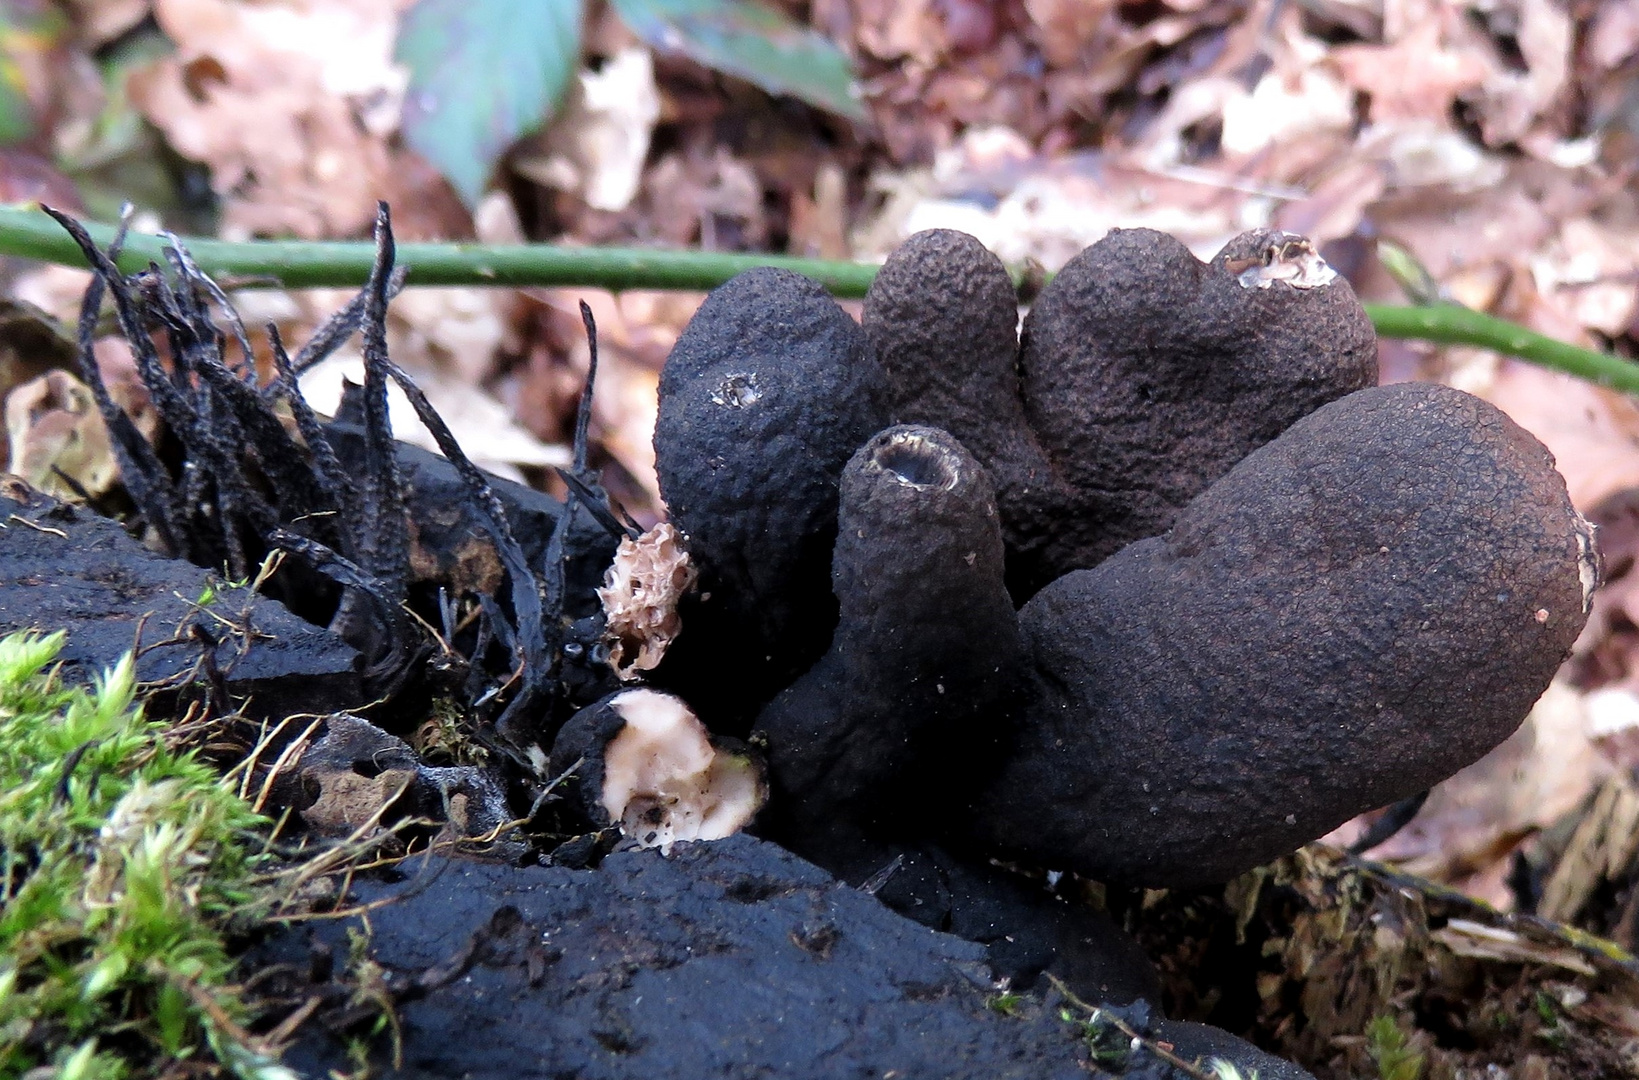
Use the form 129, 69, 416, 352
552, 688, 767, 854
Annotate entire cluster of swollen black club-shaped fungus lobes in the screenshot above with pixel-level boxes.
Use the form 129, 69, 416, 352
656, 229, 1596, 885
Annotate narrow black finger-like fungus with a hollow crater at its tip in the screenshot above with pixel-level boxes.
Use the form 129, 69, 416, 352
757, 426, 1023, 828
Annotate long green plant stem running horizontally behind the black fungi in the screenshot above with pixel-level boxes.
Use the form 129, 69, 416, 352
0, 206, 1639, 395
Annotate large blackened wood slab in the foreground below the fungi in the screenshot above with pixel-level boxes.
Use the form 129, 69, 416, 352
247, 836, 1088, 1080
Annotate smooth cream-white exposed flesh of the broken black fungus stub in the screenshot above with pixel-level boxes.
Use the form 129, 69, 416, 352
603, 690, 764, 854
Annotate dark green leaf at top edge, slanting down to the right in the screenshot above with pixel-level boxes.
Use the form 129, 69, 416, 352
611, 0, 865, 120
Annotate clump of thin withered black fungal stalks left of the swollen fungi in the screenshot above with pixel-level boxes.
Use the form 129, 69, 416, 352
39, 205, 621, 765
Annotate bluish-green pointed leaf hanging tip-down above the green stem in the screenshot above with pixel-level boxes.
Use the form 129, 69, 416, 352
395, 0, 582, 206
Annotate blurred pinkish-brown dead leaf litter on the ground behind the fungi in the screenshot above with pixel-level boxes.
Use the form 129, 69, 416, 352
5, 3, 1639, 1075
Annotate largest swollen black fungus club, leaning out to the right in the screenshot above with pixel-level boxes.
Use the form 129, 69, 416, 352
975, 383, 1595, 887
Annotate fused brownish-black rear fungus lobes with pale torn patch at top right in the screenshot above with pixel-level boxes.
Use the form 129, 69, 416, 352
864, 229, 1377, 600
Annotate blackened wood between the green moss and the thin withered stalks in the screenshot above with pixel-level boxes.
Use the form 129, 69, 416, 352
0, 480, 362, 718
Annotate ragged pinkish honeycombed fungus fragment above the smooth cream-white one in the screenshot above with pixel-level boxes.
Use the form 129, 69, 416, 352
598, 521, 697, 680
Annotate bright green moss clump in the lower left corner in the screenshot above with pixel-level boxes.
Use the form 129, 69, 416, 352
0, 634, 293, 1080
